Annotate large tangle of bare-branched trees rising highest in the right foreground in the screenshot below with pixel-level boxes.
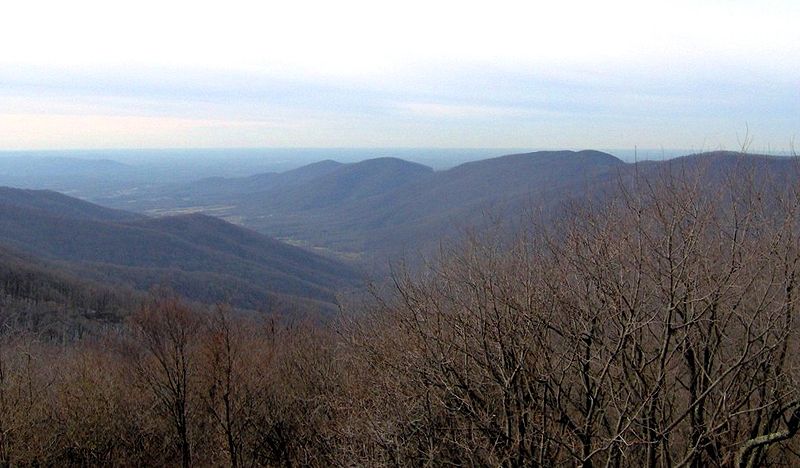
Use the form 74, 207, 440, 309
353, 156, 800, 466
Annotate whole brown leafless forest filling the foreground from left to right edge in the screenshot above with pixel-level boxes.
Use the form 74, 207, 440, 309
0, 159, 800, 467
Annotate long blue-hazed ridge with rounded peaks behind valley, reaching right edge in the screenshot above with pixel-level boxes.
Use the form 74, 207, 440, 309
90, 150, 796, 265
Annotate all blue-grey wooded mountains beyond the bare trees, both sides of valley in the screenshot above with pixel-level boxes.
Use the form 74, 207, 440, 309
0, 150, 800, 322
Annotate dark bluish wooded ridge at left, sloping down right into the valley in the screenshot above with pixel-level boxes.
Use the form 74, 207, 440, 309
0, 186, 357, 308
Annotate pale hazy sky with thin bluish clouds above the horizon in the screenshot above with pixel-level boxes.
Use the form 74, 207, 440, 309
0, 0, 800, 150
